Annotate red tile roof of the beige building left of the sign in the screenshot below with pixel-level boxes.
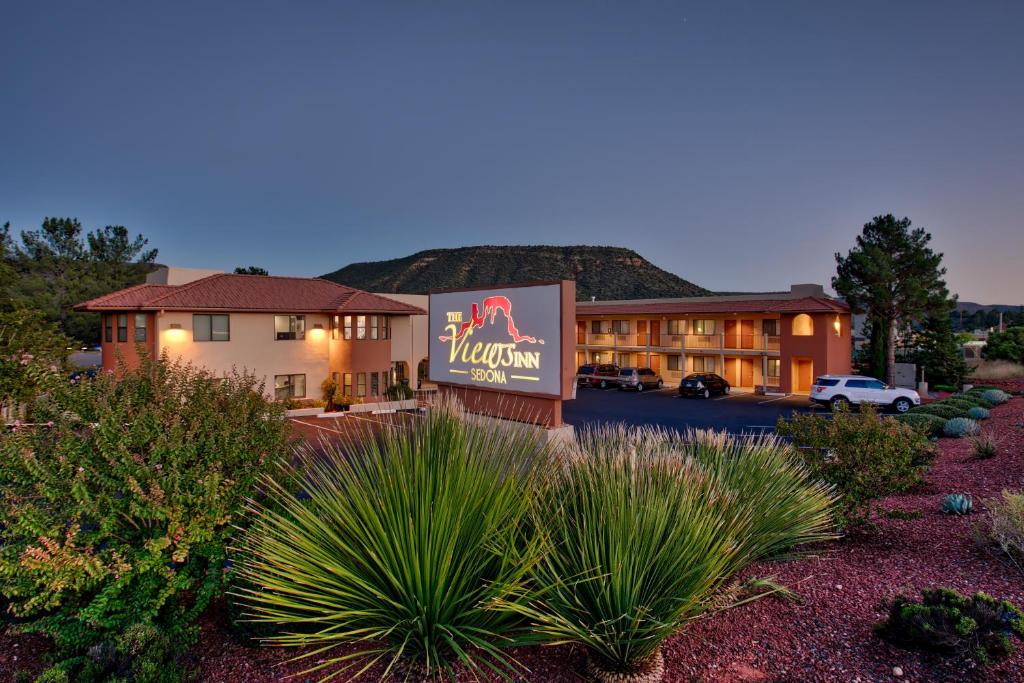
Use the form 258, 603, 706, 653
75, 273, 426, 315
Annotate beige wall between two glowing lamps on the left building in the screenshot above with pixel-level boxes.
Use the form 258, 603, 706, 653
156, 311, 329, 398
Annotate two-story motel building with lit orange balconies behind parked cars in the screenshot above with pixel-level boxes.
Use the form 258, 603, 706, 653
577, 285, 852, 393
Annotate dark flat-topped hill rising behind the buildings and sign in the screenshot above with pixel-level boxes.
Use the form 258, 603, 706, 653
322, 246, 712, 301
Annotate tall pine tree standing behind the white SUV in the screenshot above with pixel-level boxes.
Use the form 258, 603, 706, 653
831, 214, 950, 384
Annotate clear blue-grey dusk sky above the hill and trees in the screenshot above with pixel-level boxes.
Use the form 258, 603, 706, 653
0, 0, 1024, 304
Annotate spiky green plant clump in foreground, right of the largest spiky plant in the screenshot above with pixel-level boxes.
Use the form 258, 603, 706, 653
522, 427, 834, 680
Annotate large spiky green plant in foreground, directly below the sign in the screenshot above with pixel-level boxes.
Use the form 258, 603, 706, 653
234, 402, 544, 679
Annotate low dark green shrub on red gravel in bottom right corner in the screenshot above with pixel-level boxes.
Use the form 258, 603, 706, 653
876, 588, 1024, 664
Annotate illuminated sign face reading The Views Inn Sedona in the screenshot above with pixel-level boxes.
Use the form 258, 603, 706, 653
429, 284, 562, 398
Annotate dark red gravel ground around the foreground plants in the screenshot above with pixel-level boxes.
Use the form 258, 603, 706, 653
0, 397, 1024, 683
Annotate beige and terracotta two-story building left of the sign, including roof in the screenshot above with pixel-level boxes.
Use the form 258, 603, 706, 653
75, 267, 426, 399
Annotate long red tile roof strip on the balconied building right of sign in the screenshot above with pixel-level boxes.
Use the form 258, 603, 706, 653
577, 297, 850, 315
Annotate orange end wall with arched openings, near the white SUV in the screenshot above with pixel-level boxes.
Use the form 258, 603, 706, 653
779, 313, 853, 393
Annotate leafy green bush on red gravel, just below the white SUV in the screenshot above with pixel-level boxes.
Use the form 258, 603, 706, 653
776, 405, 934, 523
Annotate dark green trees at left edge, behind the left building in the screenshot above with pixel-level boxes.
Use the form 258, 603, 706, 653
5, 218, 157, 343
